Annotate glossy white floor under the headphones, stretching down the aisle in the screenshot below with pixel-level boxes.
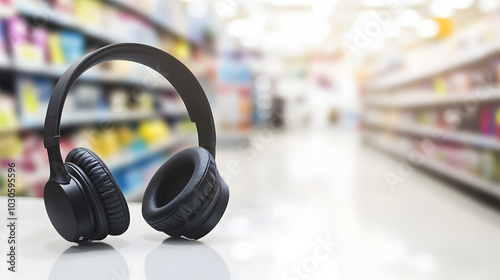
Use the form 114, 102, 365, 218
0, 131, 500, 280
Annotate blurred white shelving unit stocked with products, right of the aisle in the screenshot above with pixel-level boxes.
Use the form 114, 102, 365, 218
363, 7, 500, 199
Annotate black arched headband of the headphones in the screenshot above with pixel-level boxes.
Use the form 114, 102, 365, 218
43, 43, 216, 182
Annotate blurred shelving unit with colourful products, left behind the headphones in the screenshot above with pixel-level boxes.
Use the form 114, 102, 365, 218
0, 0, 251, 200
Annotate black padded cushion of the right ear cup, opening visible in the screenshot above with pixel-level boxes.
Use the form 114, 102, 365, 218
142, 147, 222, 237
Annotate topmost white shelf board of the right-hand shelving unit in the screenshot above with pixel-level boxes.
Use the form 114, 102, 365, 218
368, 43, 500, 91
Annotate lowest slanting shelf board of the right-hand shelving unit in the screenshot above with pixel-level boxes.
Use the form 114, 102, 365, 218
367, 133, 500, 199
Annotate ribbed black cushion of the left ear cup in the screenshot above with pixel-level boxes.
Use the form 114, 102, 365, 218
66, 148, 130, 235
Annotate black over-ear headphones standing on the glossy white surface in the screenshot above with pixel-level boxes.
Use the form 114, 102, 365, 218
44, 43, 229, 242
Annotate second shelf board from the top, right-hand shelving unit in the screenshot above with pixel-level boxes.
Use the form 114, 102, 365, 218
367, 87, 500, 108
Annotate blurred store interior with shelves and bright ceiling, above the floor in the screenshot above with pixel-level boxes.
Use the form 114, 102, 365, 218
0, 0, 500, 200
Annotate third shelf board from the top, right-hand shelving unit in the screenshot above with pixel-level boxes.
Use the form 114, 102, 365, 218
367, 122, 500, 151
